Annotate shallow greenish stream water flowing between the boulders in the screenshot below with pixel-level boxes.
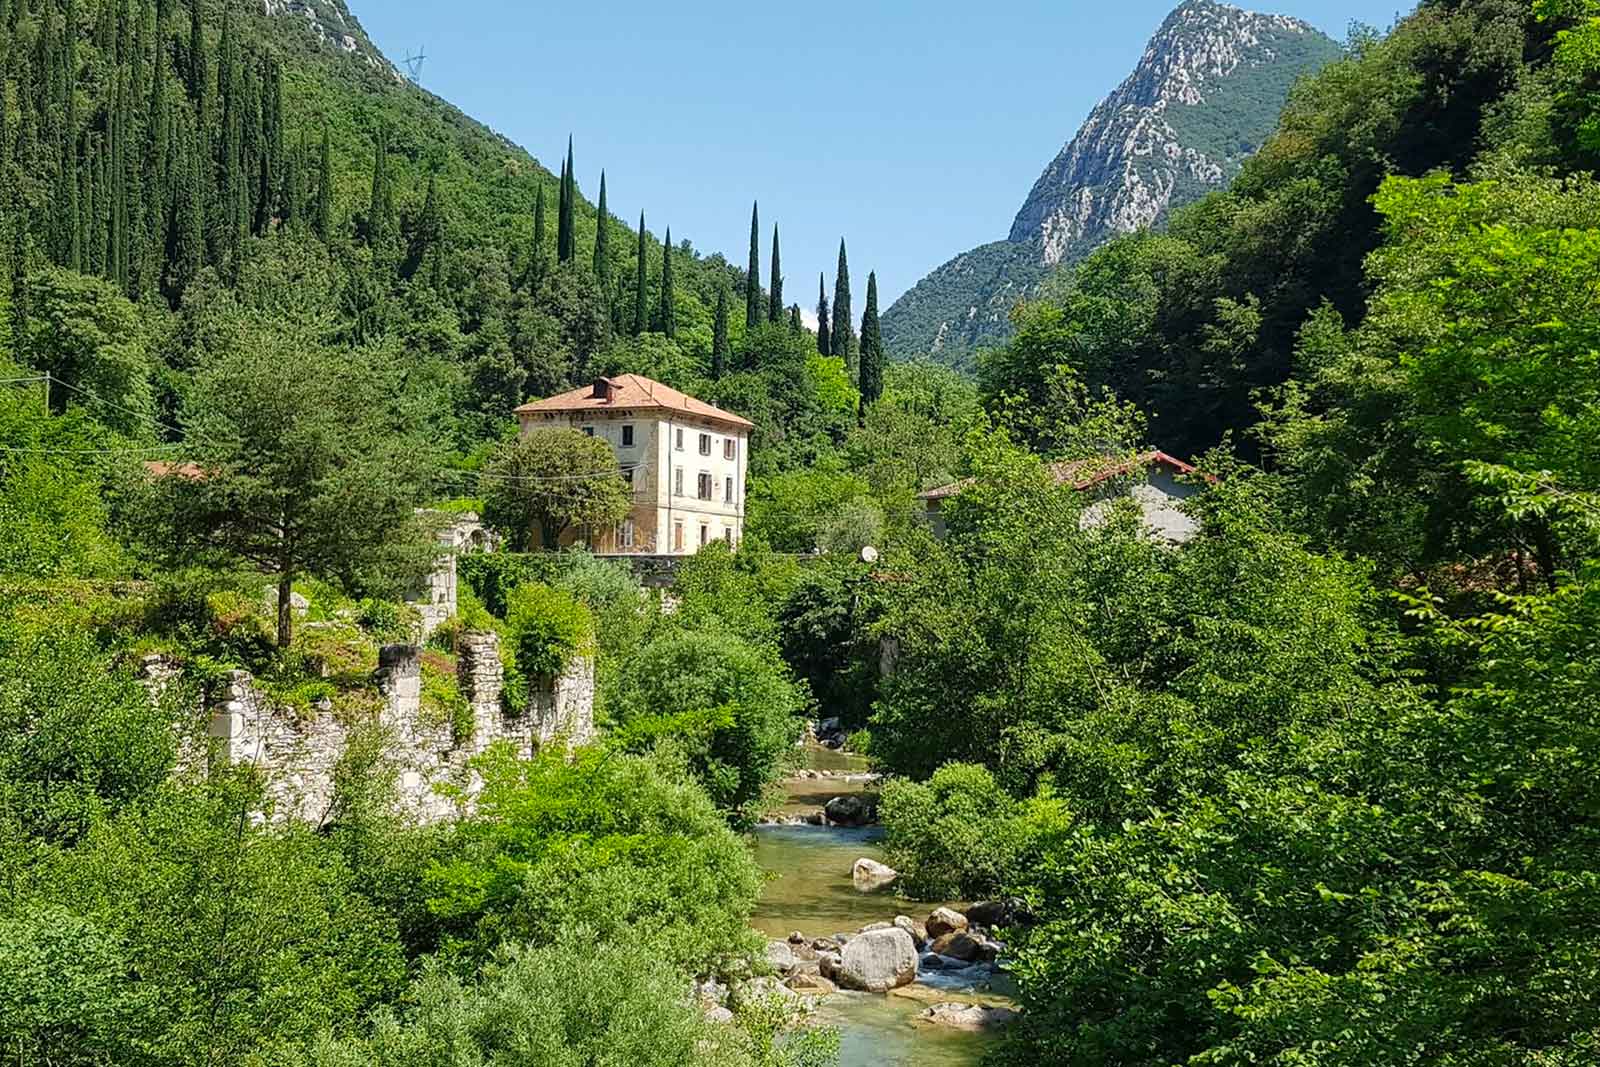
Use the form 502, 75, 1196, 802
750, 749, 1006, 1067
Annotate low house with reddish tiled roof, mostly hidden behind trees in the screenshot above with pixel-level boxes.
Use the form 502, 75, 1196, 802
918, 450, 1200, 545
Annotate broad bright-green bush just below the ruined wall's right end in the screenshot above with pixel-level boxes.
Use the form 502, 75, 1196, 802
426, 745, 762, 973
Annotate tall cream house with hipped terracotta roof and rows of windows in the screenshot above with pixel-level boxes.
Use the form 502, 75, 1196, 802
517, 374, 752, 557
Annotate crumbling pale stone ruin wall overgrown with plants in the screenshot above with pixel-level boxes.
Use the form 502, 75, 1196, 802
193, 633, 594, 825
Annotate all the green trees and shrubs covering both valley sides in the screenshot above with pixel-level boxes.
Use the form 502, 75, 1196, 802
0, 0, 1600, 1067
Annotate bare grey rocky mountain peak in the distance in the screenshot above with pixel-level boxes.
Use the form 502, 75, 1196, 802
883, 0, 1339, 363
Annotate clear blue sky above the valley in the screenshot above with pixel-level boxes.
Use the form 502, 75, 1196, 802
350, 0, 1411, 314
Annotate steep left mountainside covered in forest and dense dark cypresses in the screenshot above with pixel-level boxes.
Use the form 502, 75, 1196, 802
0, 0, 774, 451
